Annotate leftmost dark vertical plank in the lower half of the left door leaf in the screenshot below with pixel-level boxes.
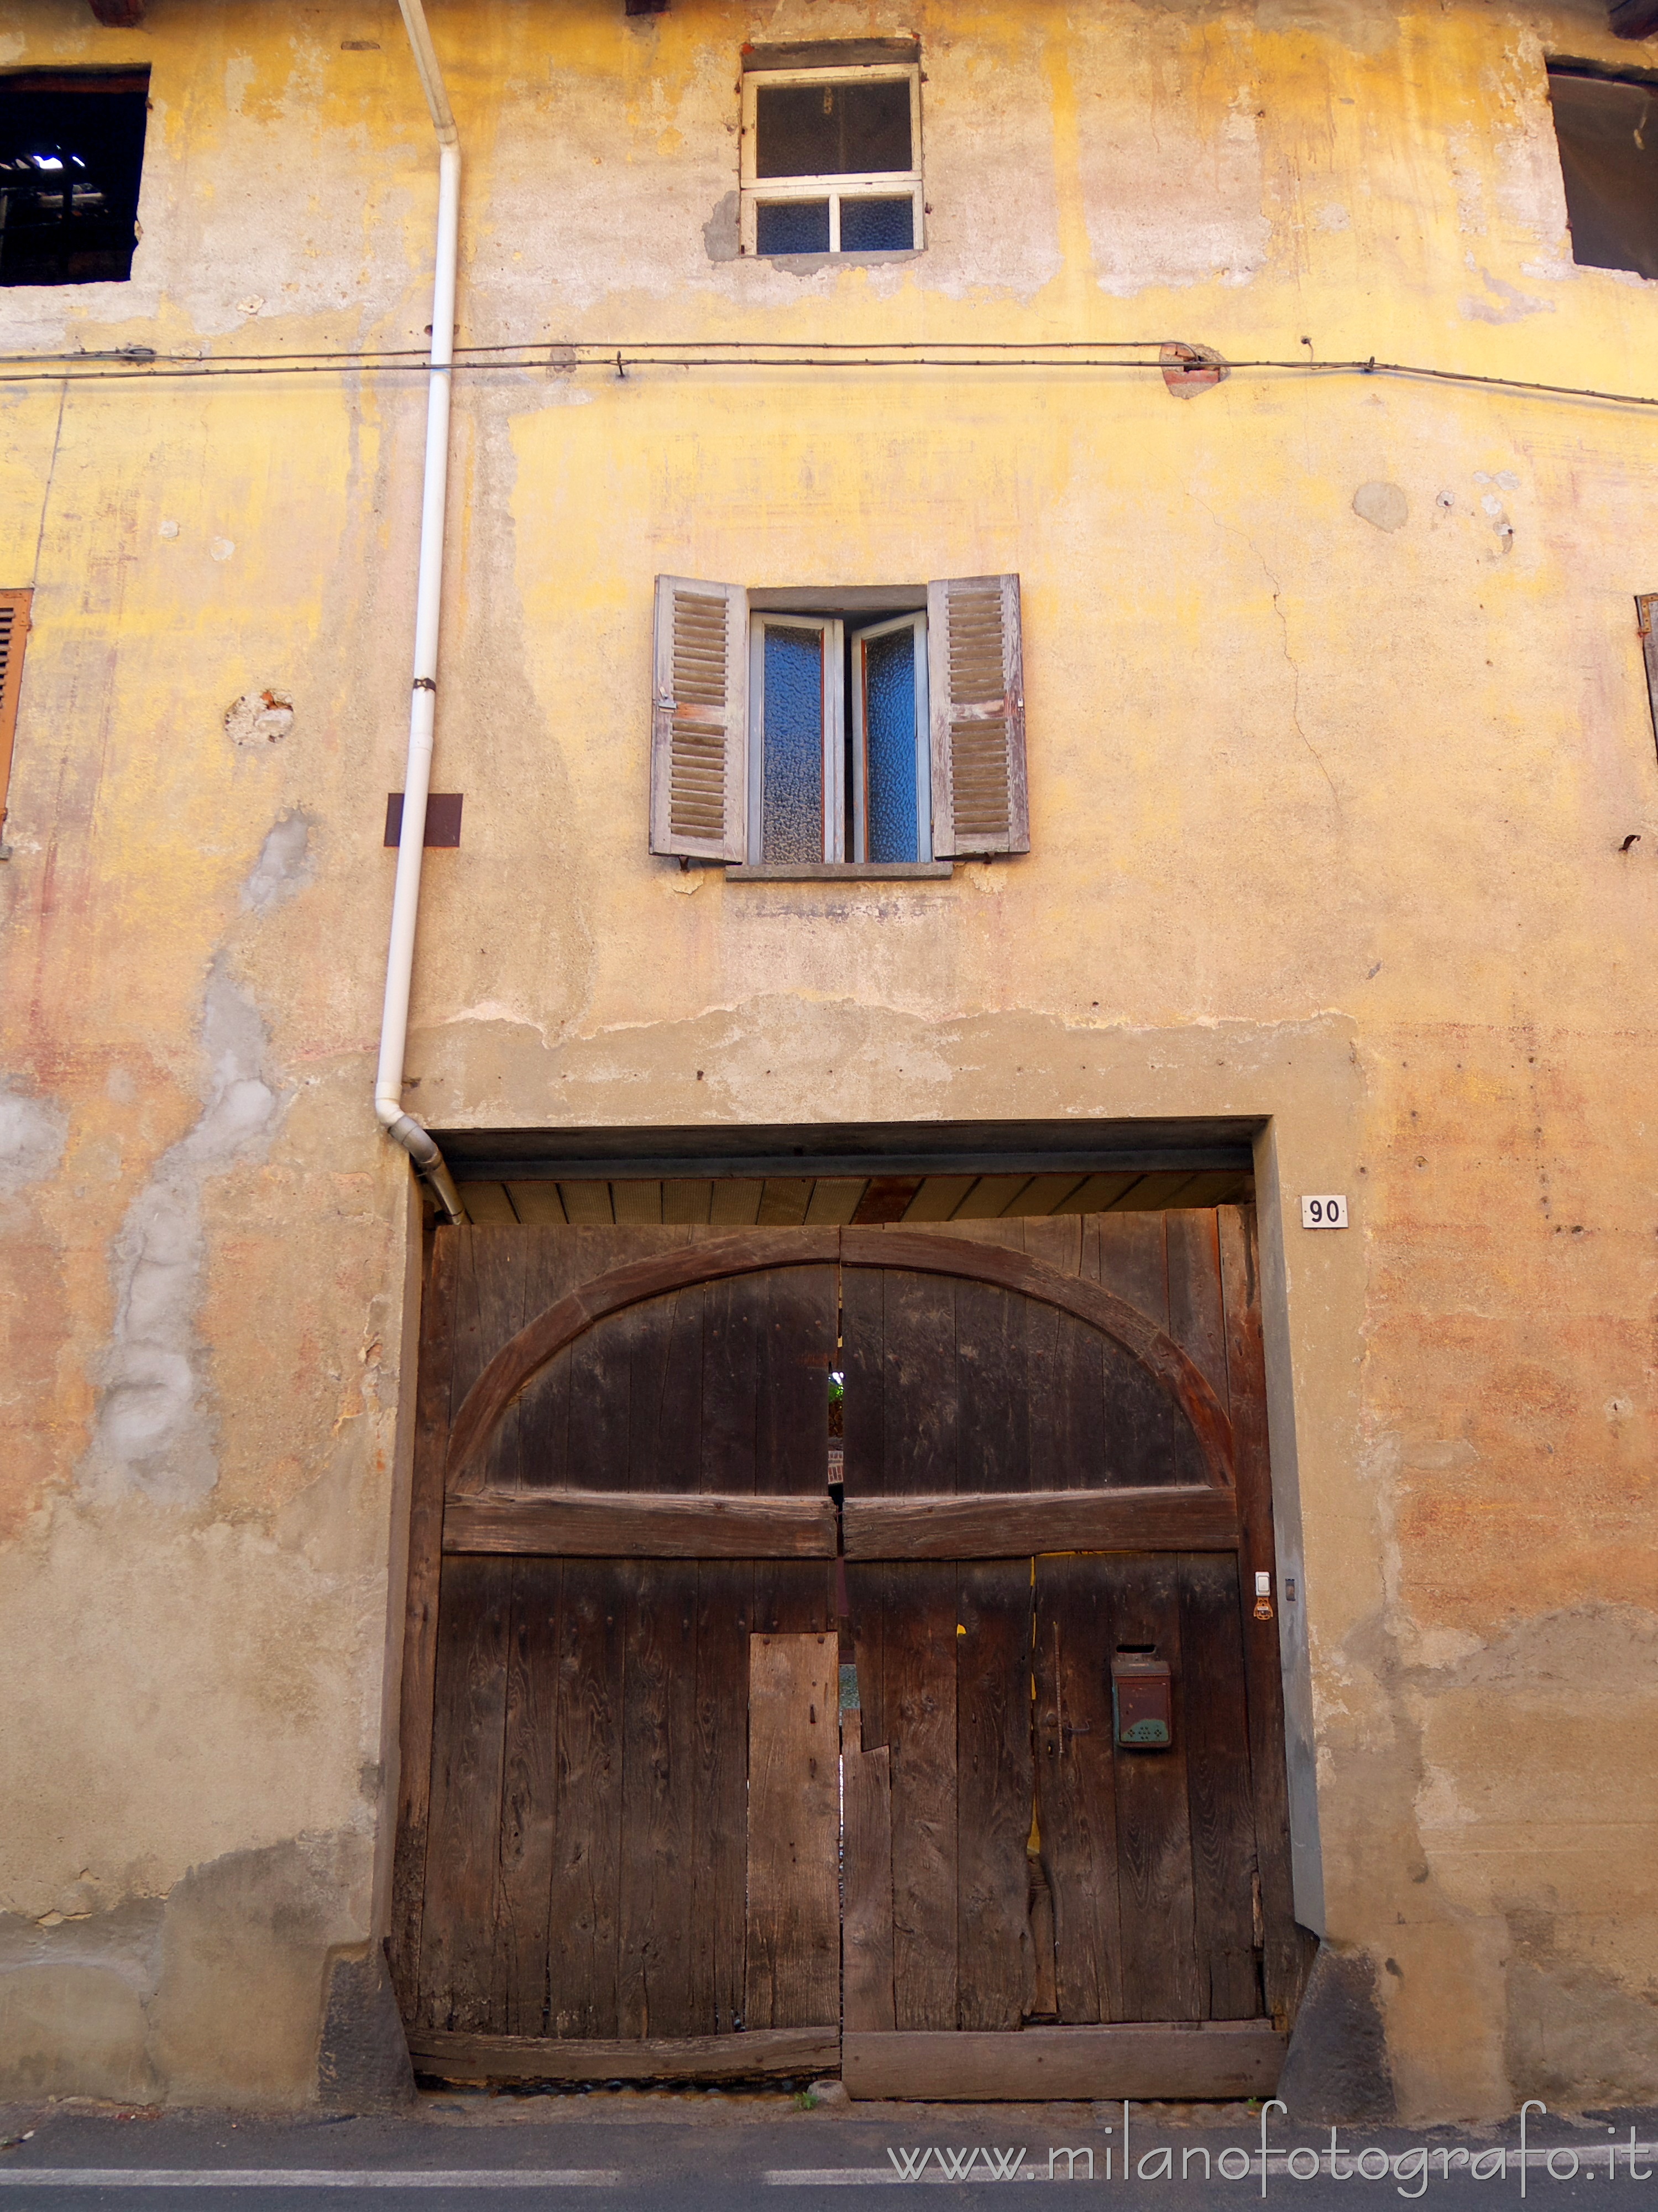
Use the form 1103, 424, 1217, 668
420, 1557, 513, 2033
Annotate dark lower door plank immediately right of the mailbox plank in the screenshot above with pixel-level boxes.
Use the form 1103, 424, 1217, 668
1176, 1553, 1262, 2020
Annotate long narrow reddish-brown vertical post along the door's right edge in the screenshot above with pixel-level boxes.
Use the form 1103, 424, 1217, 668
1218, 1206, 1311, 2024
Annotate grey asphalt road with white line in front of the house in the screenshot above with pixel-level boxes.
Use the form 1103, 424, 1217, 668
0, 2095, 1658, 2212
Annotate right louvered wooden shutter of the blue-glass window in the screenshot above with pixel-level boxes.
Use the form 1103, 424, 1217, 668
926, 575, 1030, 860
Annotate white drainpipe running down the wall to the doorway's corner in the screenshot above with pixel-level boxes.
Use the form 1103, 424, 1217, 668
374, 0, 467, 1221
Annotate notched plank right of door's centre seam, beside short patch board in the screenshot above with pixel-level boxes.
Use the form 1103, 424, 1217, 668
846, 1562, 959, 2028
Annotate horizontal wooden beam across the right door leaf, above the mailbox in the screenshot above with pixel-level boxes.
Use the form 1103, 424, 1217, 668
842, 1486, 1238, 1559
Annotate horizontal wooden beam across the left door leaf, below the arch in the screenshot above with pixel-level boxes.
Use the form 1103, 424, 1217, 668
444, 1491, 835, 1559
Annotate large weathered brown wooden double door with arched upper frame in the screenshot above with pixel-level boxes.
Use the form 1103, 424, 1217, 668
394, 1208, 1302, 2097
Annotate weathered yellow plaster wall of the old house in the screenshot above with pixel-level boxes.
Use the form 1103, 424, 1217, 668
0, 0, 1658, 2117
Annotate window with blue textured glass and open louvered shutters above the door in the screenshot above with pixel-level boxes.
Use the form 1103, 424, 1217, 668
650, 575, 1030, 869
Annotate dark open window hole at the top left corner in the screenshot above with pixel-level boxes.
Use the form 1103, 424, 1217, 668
0, 71, 150, 285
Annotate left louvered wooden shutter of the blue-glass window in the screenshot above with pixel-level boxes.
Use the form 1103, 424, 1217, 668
650, 575, 750, 860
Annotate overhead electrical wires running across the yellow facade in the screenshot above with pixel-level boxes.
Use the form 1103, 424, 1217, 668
0, 338, 1658, 407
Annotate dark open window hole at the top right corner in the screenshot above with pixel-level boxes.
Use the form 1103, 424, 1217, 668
1550, 69, 1658, 276
